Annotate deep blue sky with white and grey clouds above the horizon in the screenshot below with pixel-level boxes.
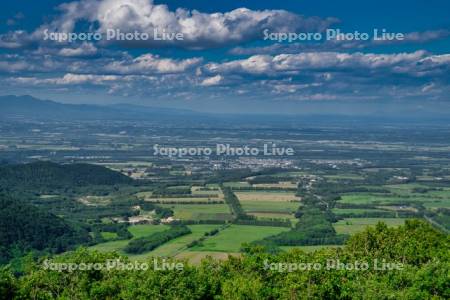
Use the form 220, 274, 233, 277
0, 0, 450, 113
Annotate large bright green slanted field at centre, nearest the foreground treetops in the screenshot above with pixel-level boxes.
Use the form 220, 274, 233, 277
191, 225, 289, 252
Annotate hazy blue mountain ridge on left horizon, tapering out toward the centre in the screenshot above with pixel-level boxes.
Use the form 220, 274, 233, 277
0, 96, 201, 120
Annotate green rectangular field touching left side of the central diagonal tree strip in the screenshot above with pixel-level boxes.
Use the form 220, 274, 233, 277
161, 204, 232, 220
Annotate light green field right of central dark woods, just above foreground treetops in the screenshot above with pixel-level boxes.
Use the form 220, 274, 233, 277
333, 218, 405, 234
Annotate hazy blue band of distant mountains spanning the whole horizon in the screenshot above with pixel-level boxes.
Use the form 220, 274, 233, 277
0, 95, 450, 127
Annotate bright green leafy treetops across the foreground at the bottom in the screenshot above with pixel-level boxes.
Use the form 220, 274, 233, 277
0, 220, 450, 299
